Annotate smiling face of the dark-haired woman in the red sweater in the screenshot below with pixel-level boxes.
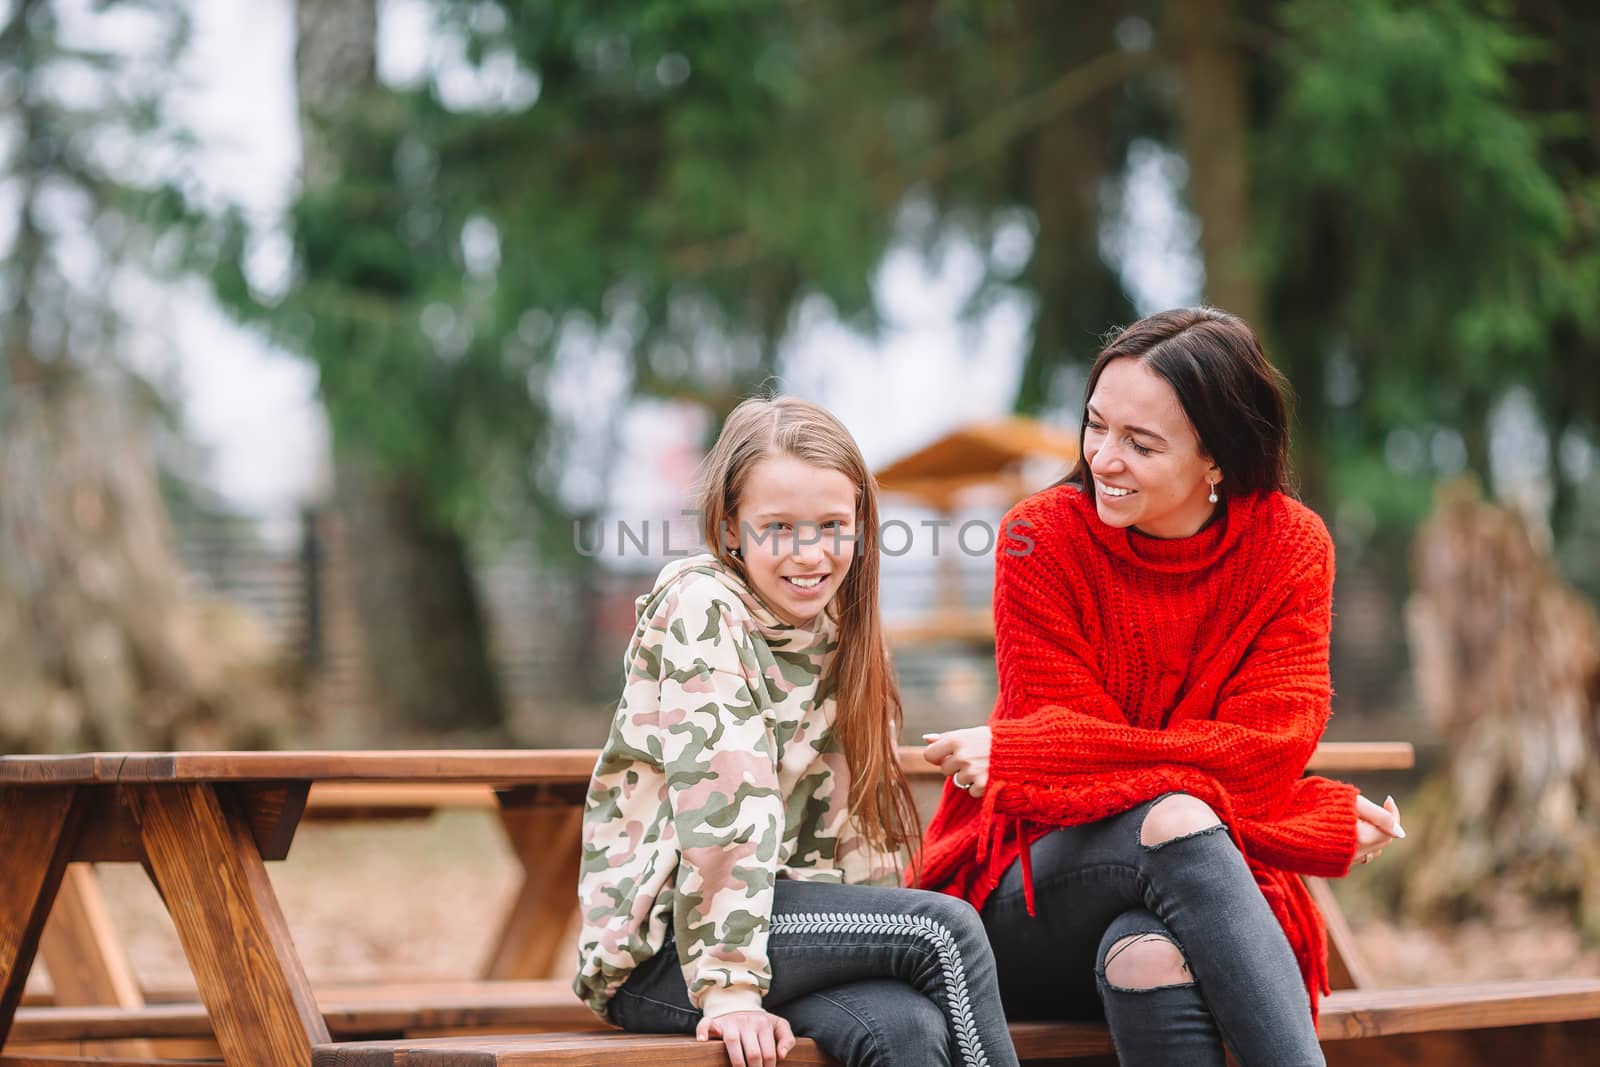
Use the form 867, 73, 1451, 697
1083, 358, 1222, 537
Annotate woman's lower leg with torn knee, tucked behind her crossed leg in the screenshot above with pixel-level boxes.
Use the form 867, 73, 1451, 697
1094, 909, 1227, 1067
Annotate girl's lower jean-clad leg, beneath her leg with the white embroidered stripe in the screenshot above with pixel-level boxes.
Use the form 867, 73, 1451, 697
778, 977, 950, 1067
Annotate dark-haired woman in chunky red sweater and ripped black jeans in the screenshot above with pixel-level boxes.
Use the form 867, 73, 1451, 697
923, 307, 1403, 1067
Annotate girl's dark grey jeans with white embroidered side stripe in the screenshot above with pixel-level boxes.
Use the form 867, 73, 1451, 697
610, 878, 1018, 1067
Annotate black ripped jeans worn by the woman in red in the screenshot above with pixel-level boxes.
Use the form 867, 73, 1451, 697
982, 798, 1325, 1067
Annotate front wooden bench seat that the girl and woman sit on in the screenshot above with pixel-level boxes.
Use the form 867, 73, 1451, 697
302, 979, 1600, 1067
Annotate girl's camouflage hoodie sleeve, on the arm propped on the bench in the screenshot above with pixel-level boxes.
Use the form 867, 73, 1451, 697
659, 582, 784, 1017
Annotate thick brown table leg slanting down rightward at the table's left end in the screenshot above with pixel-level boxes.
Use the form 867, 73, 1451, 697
128, 784, 328, 1067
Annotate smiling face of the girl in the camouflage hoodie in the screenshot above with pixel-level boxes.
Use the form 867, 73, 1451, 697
733, 453, 856, 625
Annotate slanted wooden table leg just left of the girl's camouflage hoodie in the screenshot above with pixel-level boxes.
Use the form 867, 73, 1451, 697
483, 806, 584, 979
